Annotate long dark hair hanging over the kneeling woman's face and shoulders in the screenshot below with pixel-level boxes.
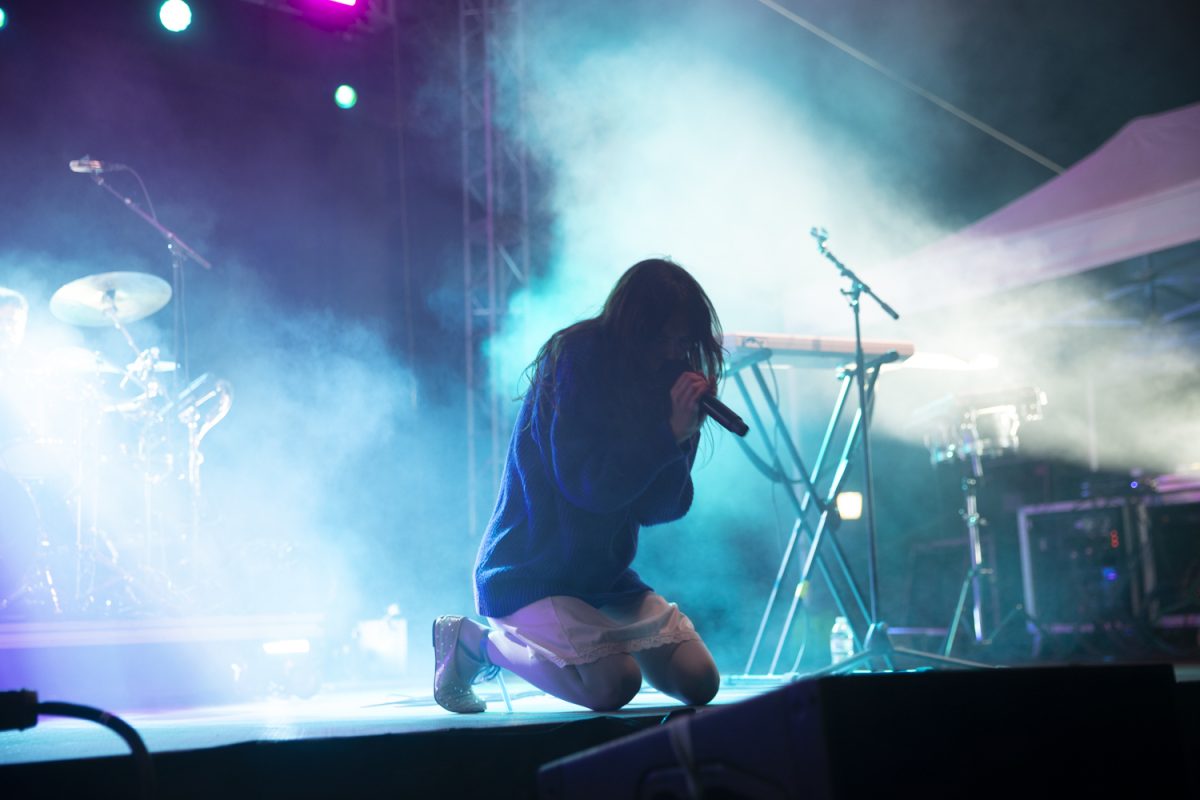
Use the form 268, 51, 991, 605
527, 258, 725, 424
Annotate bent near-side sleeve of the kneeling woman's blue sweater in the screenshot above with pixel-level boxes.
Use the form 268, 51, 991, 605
533, 340, 686, 513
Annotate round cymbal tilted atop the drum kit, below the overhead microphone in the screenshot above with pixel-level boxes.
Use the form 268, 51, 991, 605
50, 272, 170, 327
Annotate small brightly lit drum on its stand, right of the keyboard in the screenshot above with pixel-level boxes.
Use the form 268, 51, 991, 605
913, 386, 1046, 655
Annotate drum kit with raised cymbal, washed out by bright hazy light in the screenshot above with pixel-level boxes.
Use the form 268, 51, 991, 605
0, 272, 233, 621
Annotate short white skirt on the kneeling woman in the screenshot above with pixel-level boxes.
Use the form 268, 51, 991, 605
491, 591, 700, 667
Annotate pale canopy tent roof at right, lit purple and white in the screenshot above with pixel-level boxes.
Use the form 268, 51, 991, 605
872, 103, 1200, 312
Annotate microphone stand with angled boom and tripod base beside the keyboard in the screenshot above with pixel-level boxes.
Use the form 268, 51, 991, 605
809, 228, 988, 676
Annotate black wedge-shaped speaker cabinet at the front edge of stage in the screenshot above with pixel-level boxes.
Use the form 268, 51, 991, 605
539, 664, 1187, 800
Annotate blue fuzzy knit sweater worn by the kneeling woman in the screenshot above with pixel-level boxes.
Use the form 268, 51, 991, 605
475, 331, 698, 616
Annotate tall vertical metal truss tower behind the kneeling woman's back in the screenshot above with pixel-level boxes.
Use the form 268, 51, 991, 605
458, 0, 529, 536
